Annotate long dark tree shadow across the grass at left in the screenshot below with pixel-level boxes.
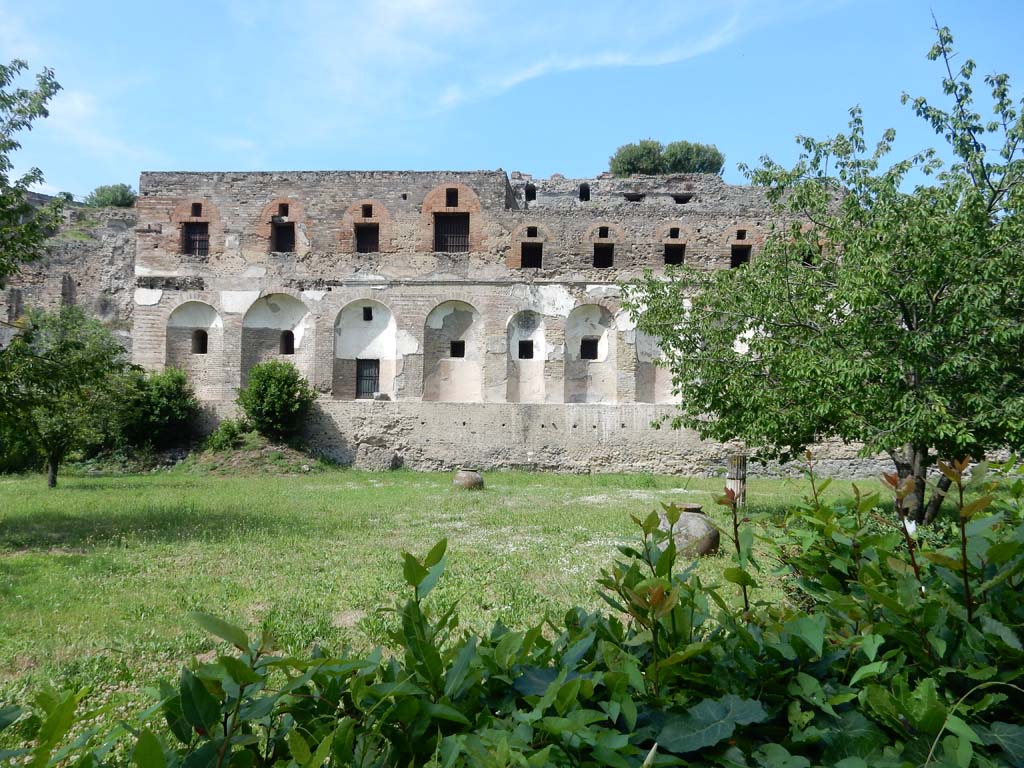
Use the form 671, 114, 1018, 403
0, 504, 282, 556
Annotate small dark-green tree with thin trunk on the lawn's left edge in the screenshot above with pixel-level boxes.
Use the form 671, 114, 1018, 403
0, 306, 127, 487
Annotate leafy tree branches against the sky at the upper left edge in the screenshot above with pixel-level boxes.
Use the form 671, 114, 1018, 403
0, 59, 62, 286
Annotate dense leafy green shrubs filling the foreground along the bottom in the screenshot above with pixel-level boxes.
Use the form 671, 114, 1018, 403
5, 465, 1024, 768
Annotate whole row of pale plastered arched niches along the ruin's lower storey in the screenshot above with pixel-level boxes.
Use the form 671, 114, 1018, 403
165, 294, 672, 402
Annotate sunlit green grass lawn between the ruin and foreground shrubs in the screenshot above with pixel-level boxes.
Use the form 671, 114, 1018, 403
0, 468, 849, 729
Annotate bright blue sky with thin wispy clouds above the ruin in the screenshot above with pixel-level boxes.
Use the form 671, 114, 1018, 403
0, 0, 1024, 196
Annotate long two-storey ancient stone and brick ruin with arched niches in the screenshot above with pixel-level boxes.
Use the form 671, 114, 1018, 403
0, 170, 880, 473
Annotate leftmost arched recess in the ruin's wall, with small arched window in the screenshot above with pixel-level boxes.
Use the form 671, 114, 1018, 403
164, 301, 224, 399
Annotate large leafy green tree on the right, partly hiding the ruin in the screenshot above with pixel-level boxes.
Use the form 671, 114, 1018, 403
628, 28, 1024, 521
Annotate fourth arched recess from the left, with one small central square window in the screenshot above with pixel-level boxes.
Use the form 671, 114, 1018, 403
423, 301, 484, 402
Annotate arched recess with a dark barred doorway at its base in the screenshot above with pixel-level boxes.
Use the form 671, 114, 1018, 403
332, 299, 398, 400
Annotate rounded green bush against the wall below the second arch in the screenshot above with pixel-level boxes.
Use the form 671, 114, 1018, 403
238, 360, 316, 439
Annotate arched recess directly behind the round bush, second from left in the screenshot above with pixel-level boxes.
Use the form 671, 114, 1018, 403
242, 293, 314, 386
